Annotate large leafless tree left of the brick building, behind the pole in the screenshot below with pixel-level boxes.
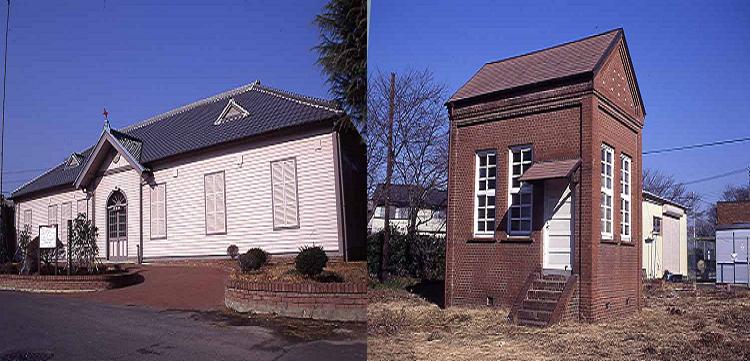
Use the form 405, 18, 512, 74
367, 70, 449, 234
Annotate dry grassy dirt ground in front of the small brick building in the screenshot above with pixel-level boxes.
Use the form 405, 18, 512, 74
367, 285, 750, 361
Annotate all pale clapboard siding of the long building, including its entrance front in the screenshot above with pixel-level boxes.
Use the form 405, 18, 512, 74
17, 133, 341, 259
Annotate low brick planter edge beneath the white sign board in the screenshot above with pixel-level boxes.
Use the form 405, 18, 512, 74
0, 271, 140, 293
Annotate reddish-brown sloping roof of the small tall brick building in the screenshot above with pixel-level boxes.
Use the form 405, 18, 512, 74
448, 29, 623, 103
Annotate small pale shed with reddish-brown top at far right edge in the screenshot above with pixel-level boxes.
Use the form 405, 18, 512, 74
716, 201, 750, 284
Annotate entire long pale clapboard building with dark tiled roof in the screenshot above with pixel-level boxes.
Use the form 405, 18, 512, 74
12, 82, 366, 261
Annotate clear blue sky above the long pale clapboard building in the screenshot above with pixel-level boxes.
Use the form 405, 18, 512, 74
0, 0, 330, 192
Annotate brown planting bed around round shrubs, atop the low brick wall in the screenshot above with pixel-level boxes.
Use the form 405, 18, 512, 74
229, 261, 367, 284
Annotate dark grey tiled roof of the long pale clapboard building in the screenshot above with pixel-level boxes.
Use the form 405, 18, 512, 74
11, 82, 343, 198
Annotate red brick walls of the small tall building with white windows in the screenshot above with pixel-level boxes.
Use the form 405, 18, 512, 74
446, 38, 643, 322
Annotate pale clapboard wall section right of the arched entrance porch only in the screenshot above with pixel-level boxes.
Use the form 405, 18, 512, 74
143, 134, 340, 257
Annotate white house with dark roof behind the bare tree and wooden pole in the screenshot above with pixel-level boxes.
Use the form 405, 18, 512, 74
367, 184, 448, 236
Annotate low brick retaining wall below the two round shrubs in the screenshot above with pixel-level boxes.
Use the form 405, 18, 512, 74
224, 279, 367, 321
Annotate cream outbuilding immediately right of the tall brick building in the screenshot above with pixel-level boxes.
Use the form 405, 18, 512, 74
642, 191, 688, 278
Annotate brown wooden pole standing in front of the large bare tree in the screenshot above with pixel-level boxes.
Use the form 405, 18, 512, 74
378, 73, 396, 282
